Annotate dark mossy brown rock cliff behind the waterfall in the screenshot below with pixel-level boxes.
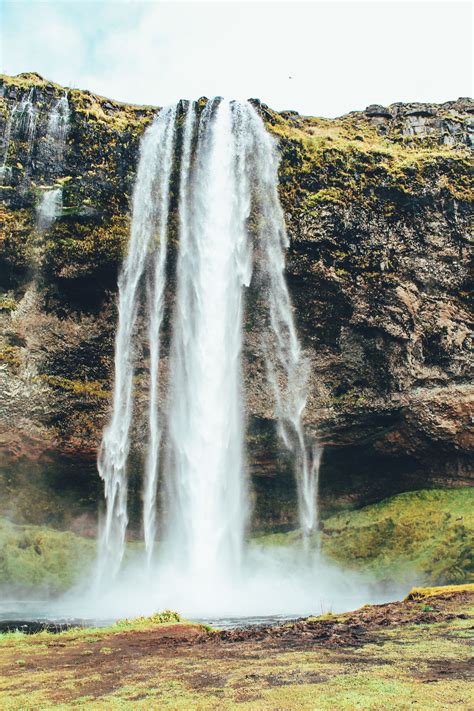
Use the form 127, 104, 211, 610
0, 74, 474, 528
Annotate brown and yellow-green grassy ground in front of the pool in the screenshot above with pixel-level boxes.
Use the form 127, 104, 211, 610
0, 585, 474, 711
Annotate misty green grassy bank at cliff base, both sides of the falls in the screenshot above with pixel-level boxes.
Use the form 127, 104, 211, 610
0, 488, 474, 595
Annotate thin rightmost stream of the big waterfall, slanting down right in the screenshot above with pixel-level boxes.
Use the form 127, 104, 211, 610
243, 112, 320, 534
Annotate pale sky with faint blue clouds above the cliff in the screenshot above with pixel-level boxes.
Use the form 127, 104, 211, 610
0, 0, 473, 117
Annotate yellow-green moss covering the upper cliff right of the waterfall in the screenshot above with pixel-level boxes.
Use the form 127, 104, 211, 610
267, 107, 474, 218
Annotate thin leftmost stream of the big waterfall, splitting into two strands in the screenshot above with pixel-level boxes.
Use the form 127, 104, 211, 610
98, 107, 176, 581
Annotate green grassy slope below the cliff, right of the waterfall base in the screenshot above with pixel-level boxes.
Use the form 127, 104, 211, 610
256, 487, 474, 585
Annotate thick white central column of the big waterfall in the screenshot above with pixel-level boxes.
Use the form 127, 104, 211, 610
162, 100, 251, 578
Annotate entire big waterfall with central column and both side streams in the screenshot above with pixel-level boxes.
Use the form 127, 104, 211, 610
98, 98, 320, 584
